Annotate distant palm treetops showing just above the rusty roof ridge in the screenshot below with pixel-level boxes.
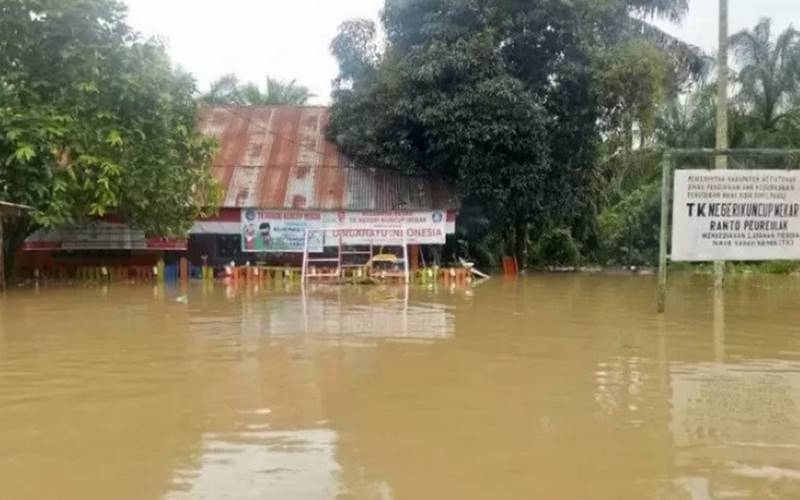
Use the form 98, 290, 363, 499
201, 74, 315, 106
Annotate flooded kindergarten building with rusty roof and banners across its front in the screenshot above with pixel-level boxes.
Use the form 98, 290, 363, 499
21, 106, 458, 278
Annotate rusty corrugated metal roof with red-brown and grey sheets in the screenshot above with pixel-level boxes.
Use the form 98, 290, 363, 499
200, 106, 458, 210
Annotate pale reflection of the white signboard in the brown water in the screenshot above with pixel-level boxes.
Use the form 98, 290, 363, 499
670, 360, 800, 498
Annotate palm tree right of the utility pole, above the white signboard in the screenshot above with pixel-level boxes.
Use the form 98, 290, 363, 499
730, 19, 800, 132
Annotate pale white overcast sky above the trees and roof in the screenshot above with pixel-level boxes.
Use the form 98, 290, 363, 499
125, 0, 800, 103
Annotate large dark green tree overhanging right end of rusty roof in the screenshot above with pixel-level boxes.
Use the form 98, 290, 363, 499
329, 0, 696, 263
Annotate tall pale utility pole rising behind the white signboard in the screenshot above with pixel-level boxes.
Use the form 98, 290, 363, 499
714, 0, 728, 288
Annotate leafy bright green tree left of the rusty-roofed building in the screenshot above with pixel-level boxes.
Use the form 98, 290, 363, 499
0, 0, 219, 282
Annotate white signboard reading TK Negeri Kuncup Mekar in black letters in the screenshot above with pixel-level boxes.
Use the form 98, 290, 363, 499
671, 170, 800, 261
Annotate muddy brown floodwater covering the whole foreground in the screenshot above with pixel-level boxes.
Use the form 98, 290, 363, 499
0, 276, 800, 500
